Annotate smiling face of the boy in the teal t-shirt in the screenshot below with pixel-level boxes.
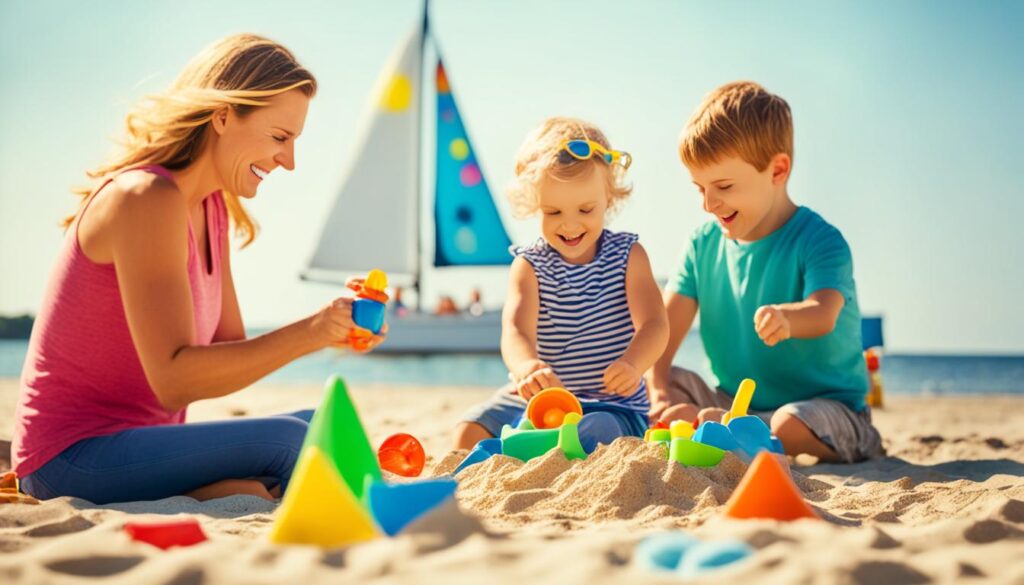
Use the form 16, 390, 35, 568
689, 155, 790, 242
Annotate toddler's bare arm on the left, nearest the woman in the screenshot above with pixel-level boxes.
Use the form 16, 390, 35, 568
502, 257, 562, 400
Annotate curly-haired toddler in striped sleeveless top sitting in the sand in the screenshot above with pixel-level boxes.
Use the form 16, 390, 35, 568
455, 118, 669, 452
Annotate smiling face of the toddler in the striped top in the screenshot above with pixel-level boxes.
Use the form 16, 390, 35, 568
538, 166, 608, 264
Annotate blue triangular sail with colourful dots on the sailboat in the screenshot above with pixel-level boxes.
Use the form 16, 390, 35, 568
434, 59, 512, 266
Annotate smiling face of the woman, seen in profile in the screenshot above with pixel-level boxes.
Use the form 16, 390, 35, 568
213, 89, 309, 198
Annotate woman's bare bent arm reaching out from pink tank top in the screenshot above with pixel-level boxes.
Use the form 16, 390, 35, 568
104, 180, 353, 410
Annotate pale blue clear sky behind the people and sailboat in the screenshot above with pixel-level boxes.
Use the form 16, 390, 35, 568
0, 0, 1024, 354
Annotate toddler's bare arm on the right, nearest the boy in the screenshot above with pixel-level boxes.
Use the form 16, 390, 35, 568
622, 243, 669, 374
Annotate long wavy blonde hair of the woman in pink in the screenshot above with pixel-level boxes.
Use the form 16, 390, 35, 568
63, 34, 316, 247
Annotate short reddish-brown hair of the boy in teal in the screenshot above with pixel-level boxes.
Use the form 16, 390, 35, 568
679, 81, 793, 171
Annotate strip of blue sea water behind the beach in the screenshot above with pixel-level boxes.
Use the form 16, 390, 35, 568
0, 336, 1024, 394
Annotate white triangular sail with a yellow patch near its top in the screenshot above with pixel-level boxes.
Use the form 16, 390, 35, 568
303, 24, 424, 284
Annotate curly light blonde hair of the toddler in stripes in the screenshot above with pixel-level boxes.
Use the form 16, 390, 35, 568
506, 117, 633, 217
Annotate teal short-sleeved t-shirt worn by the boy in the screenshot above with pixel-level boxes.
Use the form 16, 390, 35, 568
669, 207, 867, 411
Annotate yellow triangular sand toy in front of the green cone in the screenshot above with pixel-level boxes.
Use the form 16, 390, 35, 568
270, 446, 378, 548
